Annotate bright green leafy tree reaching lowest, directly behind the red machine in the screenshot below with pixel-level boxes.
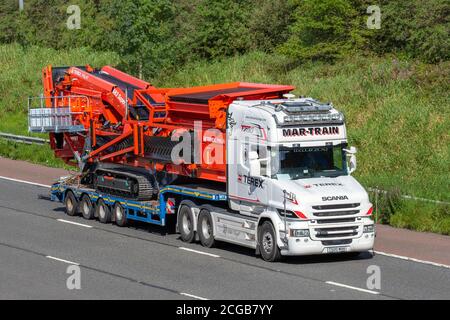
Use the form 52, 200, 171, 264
96, 0, 175, 79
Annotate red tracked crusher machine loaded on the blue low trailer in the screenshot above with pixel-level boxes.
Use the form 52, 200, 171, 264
29, 65, 294, 200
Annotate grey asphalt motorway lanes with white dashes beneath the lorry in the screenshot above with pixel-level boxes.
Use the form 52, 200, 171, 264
0, 179, 450, 300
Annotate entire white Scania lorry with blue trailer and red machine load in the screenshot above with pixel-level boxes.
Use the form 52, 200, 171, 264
28, 65, 375, 261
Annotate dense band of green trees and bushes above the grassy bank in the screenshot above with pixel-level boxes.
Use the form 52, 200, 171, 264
0, 0, 450, 78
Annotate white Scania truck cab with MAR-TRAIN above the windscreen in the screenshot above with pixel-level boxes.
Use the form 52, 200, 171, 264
219, 95, 375, 261
